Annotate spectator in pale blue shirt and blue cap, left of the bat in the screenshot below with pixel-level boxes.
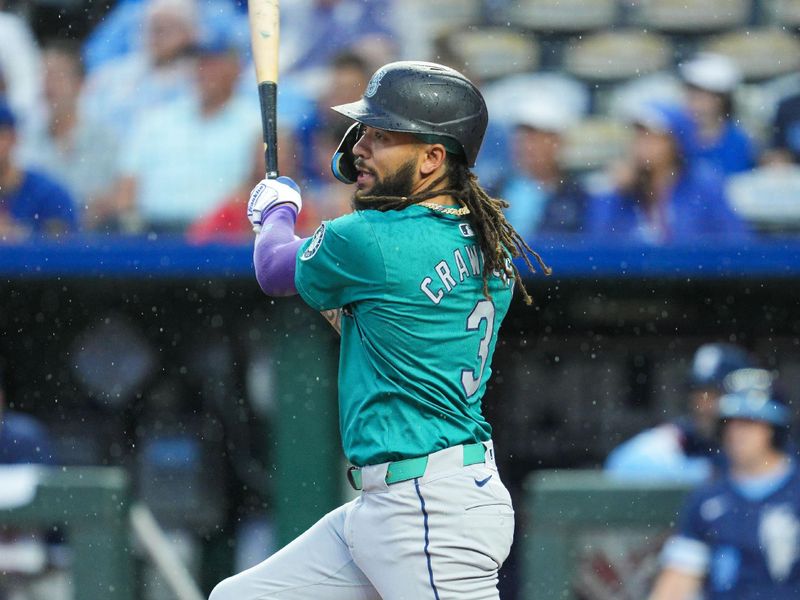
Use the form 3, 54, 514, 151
117, 33, 260, 233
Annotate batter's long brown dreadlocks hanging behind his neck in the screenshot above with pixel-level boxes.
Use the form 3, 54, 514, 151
359, 152, 552, 306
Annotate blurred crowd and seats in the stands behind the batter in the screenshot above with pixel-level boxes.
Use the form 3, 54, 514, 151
0, 0, 800, 245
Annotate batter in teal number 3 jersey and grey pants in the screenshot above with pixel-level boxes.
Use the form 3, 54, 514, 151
211, 62, 547, 600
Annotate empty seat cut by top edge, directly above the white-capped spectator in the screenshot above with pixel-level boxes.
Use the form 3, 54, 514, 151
635, 0, 752, 34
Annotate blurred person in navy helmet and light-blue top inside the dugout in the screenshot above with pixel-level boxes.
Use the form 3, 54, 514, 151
605, 344, 753, 483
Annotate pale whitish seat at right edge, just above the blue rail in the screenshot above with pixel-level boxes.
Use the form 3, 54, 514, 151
727, 165, 800, 231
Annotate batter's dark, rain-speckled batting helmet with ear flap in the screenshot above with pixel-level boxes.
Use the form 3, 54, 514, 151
331, 61, 489, 183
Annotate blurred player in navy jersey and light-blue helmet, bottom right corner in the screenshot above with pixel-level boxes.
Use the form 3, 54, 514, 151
650, 369, 800, 600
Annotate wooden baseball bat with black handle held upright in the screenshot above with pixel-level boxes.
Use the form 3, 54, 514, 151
248, 0, 280, 179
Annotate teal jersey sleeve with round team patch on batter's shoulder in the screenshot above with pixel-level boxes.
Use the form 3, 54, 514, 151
295, 212, 386, 310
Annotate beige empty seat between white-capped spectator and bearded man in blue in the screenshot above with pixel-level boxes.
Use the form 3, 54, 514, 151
562, 117, 630, 171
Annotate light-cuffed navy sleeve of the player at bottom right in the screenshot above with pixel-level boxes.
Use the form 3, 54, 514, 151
661, 493, 711, 577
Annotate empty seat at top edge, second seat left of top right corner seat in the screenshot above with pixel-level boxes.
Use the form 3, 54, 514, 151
506, 0, 618, 33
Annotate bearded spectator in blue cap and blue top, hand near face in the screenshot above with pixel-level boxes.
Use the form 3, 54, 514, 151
587, 101, 748, 245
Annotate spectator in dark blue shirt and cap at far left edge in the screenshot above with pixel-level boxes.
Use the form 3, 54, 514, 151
0, 99, 75, 243
